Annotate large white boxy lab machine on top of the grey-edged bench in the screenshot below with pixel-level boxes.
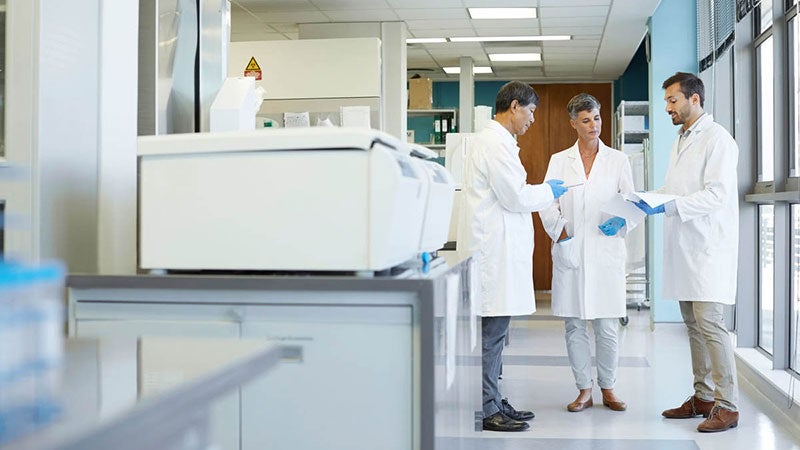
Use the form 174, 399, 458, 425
139, 128, 432, 271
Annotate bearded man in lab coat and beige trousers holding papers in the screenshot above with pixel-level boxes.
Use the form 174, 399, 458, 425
637, 72, 739, 432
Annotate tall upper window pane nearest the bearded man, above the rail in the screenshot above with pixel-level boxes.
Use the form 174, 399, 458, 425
756, 36, 775, 181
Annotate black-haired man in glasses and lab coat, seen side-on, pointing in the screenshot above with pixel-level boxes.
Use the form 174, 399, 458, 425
458, 81, 567, 431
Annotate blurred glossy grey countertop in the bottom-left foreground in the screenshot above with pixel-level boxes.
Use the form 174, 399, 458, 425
0, 337, 282, 450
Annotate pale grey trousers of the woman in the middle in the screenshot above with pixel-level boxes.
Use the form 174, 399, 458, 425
564, 317, 619, 389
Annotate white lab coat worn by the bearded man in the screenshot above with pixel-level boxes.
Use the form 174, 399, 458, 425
658, 114, 739, 305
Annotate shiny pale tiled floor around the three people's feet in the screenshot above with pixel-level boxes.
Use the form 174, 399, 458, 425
444, 302, 800, 450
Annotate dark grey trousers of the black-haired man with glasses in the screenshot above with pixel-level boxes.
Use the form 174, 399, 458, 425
481, 316, 511, 417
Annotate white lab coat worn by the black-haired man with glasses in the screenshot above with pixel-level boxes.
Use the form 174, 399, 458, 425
457, 120, 553, 316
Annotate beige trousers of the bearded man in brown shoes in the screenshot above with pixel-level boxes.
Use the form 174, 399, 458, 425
678, 302, 739, 411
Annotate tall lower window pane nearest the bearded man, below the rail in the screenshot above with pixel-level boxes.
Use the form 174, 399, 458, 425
758, 205, 775, 355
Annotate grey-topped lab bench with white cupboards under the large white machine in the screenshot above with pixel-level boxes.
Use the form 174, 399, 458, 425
66, 258, 481, 450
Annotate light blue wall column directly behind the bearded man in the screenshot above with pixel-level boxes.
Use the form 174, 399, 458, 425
648, 0, 697, 322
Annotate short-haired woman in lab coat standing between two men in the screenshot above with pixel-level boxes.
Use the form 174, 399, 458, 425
539, 94, 633, 412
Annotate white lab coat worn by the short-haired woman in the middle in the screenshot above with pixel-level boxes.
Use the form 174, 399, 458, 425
539, 142, 633, 319
